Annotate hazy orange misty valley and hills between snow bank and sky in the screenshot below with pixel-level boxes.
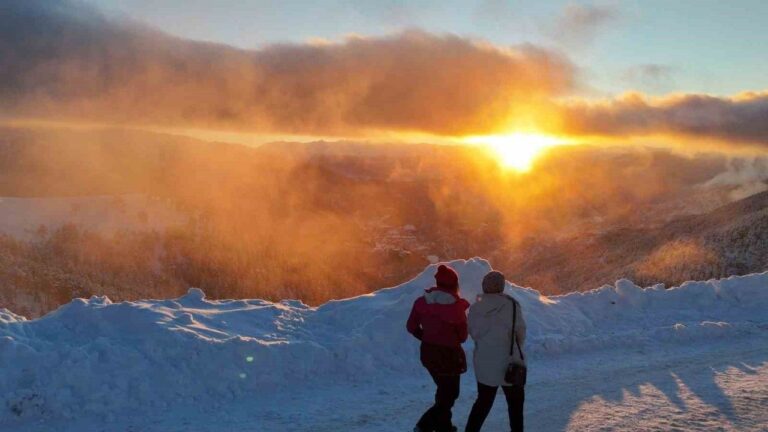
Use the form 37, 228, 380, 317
0, 127, 766, 316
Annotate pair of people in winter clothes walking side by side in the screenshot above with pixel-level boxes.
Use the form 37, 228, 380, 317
406, 265, 525, 432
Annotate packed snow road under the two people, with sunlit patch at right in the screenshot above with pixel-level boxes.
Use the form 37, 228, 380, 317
242, 329, 768, 432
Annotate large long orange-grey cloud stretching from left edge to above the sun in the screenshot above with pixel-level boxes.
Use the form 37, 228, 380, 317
0, 0, 574, 135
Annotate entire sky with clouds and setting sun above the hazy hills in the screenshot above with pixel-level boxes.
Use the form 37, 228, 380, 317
0, 0, 768, 165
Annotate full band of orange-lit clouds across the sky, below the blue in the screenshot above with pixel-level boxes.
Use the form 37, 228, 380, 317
0, 2, 768, 159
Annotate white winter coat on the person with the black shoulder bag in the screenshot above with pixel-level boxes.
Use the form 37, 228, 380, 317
469, 294, 525, 386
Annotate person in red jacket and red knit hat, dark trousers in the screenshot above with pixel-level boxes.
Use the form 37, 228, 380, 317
406, 265, 469, 432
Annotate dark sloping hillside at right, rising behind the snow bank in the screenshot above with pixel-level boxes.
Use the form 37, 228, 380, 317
500, 192, 768, 292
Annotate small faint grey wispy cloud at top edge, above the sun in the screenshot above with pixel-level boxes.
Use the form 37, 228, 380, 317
544, 3, 621, 46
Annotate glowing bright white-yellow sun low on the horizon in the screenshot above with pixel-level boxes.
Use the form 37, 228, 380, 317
465, 132, 567, 172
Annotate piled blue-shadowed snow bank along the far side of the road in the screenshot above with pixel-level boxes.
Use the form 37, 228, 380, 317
0, 258, 768, 423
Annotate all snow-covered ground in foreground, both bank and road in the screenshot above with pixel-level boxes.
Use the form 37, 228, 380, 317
0, 259, 768, 432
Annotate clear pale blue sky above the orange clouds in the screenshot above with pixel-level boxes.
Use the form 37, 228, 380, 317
94, 0, 768, 95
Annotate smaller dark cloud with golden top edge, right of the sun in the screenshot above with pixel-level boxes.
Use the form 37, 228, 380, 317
561, 92, 768, 146
